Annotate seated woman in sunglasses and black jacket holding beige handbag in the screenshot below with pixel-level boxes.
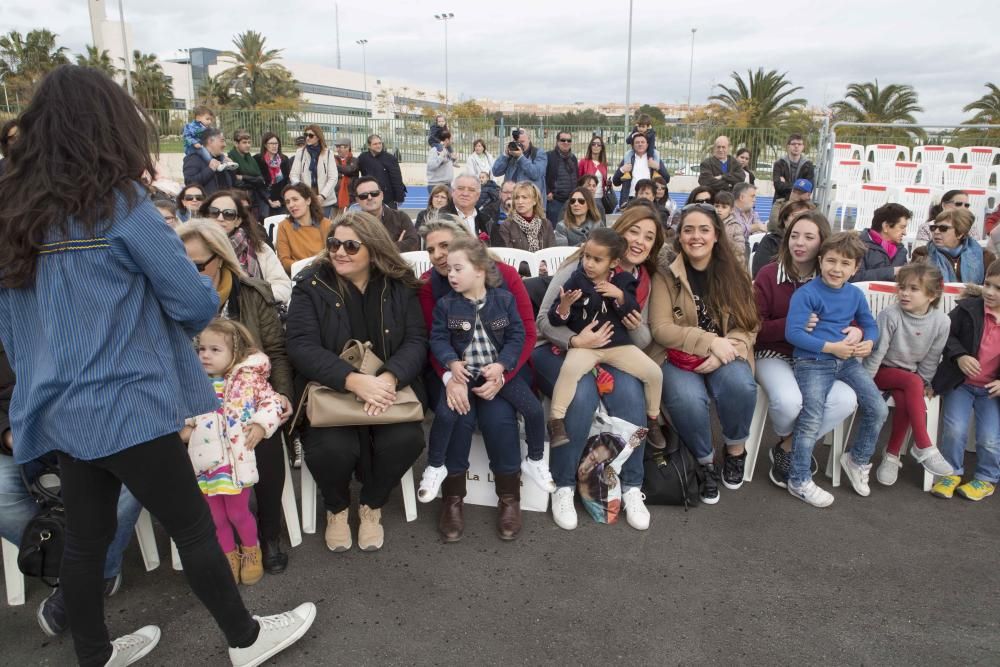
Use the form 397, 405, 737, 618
285, 211, 428, 552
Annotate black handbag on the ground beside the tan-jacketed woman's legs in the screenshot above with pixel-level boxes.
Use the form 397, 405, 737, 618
642, 424, 701, 509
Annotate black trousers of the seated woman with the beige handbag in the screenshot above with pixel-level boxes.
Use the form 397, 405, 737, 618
302, 422, 424, 514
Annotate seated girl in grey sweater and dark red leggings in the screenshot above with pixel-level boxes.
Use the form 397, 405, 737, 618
864, 264, 954, 486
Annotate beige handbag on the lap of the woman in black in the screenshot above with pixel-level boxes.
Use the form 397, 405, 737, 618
292, 339, 424, 427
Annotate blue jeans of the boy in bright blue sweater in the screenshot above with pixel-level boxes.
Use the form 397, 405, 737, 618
788, 359, 889, 486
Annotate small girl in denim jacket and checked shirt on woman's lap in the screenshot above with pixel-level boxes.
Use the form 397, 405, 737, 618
417, 238, 556, 503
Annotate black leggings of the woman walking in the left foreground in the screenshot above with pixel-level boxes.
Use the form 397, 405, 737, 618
59, 433, 260, 666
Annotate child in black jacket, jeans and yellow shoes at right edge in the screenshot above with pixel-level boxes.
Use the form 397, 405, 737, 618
931, 261, 1000, 500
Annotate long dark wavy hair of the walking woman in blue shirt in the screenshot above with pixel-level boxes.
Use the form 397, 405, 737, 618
0, 65, 159, 288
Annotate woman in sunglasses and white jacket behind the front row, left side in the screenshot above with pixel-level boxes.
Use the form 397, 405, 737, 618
198, 190, 292, 305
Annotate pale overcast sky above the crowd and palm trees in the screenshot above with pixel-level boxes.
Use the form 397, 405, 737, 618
0, 0, 1000, 123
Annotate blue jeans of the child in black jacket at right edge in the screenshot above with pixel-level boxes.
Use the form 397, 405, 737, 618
939, 384, 1000, 484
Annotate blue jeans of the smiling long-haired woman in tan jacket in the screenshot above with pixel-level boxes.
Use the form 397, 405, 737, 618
662, 359, 757, 464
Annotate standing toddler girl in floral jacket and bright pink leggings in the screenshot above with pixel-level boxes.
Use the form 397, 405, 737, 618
180, 319, 281, 584
